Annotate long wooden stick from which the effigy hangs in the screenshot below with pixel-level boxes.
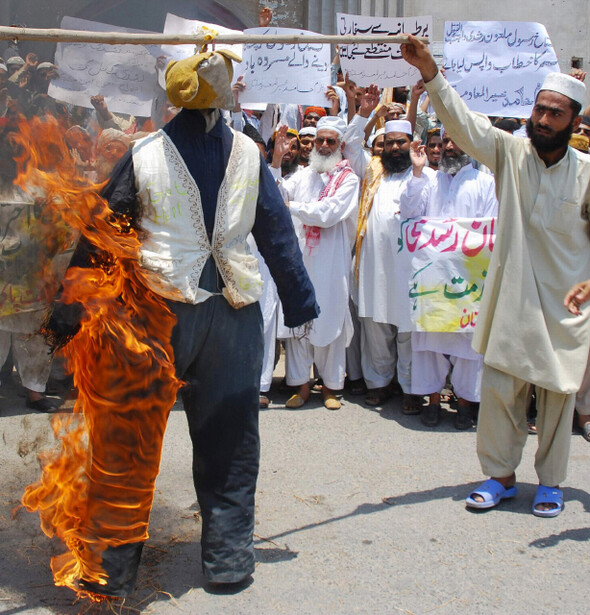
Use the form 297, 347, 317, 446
0, 26, 428, 45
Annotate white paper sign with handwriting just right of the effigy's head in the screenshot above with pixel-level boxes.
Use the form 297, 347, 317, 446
236, 28, 331, 107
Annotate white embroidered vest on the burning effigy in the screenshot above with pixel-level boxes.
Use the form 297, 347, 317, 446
133, 130, 262, 309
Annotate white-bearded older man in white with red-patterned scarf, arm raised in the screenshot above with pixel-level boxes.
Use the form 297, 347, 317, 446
271, 117, 359, 410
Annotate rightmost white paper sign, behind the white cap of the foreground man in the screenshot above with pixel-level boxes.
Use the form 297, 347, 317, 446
444, 21, 559, 117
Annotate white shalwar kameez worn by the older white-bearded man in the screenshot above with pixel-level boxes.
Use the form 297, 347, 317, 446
271, 161, 359, 390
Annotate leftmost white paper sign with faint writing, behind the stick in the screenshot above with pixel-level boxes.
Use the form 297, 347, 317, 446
48, 17, 159, 117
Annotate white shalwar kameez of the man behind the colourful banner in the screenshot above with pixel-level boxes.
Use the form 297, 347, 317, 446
400, 164, 498, 402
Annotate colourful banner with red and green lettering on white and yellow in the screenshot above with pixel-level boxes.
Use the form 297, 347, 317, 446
398, 218, 496, 333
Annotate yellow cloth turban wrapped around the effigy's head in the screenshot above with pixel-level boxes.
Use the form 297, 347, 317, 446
166, 49, 242, 109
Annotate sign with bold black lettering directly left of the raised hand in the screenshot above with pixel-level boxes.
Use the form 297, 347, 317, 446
336, 13, 432, 88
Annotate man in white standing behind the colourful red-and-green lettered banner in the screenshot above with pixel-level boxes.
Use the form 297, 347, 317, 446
400, 133, 498, 429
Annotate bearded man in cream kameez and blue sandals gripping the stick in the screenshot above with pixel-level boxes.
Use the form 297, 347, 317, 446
401, 36, 590, 517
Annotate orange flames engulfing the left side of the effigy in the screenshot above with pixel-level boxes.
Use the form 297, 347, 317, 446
13, 118, 181, 599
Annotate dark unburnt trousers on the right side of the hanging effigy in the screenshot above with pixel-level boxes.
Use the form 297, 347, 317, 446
170, 295, 264, 583
